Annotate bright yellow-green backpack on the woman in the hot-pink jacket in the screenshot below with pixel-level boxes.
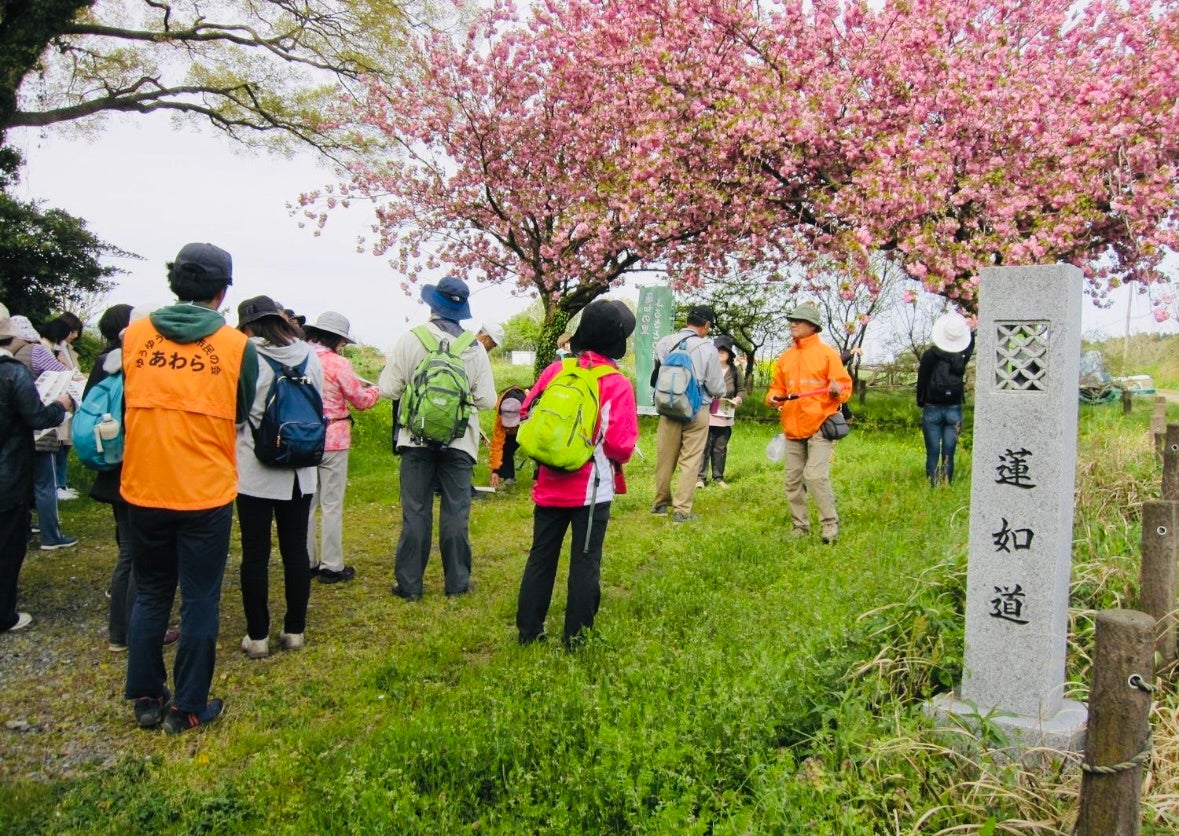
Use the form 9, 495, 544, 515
516, 357, 618, 470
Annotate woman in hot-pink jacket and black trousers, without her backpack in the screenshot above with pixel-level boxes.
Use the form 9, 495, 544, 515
516, 301, 639, 647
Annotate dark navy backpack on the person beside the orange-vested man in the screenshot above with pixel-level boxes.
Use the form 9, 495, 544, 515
250, 354, 328, 467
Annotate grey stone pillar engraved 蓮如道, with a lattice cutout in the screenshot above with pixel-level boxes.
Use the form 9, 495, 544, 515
935, 264, 1087, 750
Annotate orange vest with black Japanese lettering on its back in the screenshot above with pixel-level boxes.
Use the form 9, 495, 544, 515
120, 317, 246, 511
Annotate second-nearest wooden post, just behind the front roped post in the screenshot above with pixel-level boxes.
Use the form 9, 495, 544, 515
1138, 500, 1179, 670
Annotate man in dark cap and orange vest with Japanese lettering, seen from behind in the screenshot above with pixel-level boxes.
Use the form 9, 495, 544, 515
120, 243, 258, 735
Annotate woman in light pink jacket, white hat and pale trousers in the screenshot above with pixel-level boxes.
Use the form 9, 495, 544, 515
303, 310, 381, 584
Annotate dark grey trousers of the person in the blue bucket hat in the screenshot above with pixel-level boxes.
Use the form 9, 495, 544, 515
394, 447, 475, 598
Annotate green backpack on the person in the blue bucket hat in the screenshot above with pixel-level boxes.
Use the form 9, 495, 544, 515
397, 325, 475, 447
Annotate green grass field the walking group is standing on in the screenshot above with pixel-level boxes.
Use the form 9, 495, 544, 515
0, 367, 1179, 835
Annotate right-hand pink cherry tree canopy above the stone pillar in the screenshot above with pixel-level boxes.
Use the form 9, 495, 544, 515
668, 0, 1179, 312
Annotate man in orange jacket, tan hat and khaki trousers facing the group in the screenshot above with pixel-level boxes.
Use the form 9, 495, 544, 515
765, 303, 851, 542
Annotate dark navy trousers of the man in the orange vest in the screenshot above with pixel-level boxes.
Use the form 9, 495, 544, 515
124, 502, 233, 712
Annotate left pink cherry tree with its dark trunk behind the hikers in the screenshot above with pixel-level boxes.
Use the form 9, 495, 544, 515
301, 2, 754, 364
